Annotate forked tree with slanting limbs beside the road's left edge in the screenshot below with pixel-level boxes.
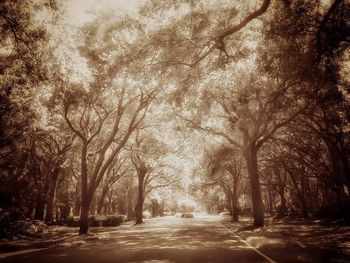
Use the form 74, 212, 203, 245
45, 9, 165, 234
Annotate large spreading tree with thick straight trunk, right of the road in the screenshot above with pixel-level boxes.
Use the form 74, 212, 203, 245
142, 1, 347, 226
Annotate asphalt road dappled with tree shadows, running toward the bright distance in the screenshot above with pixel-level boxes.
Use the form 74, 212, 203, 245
0, 217, 340, 263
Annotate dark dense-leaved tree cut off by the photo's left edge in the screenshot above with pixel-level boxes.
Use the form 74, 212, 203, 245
0, 0, 58, 217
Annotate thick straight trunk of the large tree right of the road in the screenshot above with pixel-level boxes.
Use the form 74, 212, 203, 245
245, 143, 264, 227
